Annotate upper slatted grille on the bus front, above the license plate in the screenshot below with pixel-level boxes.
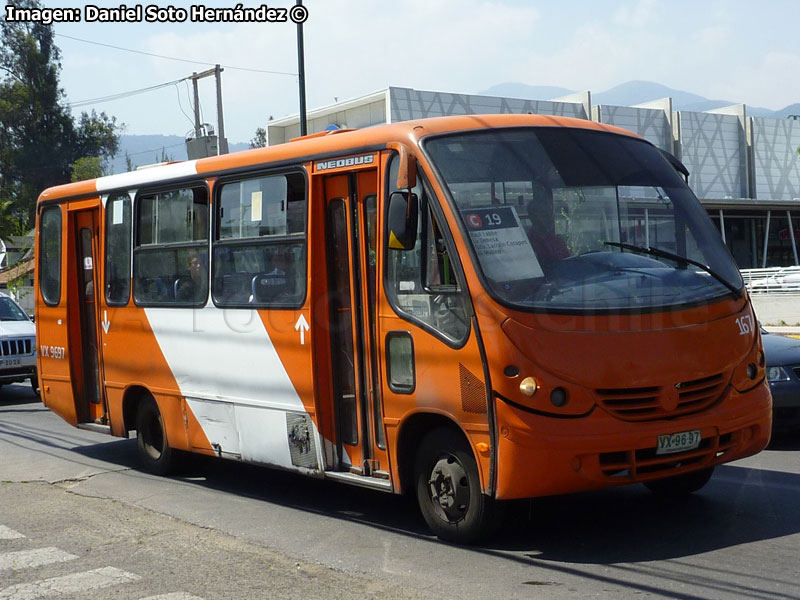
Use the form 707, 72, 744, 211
595, 373, 725, 421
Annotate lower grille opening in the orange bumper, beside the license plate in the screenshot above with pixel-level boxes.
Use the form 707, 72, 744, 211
598, 433, 735, 483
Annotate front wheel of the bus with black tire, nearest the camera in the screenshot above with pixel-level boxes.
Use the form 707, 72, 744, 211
414, 428, 496, 544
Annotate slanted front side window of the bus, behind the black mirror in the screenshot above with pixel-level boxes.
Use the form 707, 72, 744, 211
385, 159, 469, 343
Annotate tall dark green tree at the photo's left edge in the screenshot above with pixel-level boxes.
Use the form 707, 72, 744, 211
0, 0, 120, 236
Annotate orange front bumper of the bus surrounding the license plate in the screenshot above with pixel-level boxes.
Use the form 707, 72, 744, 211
495, 382, 772, 499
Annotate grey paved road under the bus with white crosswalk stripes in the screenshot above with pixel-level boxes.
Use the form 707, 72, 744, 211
0, 386, 800, 600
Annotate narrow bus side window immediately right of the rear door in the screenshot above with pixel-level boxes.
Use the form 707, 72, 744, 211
105, 194, 131, 306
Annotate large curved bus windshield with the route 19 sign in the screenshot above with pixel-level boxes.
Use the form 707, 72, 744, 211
423, 127, 744, 311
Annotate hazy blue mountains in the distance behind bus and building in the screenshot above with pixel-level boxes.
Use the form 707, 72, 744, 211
108, 81, 800, 173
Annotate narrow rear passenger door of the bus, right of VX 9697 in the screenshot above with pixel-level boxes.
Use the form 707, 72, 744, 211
68, 207, 107, 425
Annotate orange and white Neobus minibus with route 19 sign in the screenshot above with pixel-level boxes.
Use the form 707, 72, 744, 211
36, 115, 771, 542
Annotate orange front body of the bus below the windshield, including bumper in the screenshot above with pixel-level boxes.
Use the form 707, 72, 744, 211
466, 293, 771, 499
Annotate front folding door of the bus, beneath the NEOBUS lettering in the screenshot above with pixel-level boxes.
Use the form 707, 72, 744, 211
324, 169, 388, 479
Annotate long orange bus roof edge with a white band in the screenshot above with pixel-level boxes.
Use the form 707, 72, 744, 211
39, 114, 640, 202
